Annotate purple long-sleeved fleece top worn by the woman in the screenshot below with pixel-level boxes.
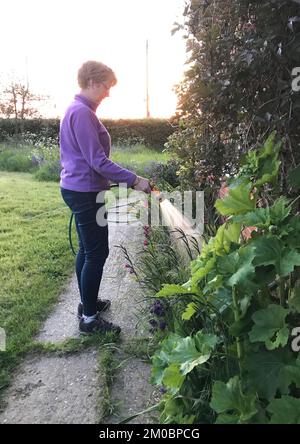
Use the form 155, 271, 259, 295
60, 94, 137, 192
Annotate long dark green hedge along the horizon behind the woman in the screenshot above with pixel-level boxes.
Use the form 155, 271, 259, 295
0, 119, 174, 150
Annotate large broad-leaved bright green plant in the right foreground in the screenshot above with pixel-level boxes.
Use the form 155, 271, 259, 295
152, 134, 300, 424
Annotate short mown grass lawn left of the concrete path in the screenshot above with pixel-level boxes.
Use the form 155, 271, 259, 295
0, 171, 74, 389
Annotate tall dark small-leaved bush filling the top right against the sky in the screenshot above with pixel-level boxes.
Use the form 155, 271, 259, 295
167, 0, 300, 191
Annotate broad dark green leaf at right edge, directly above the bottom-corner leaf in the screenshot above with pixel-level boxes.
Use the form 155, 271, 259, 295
245, 348, 300, 400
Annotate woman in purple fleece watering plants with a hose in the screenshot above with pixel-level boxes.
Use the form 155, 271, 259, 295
60, 61, 151, 333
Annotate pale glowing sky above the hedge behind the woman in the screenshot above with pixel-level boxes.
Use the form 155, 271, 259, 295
0, 0, 186, 118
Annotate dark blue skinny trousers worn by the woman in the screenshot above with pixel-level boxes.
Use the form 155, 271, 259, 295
61, 188, 109, 316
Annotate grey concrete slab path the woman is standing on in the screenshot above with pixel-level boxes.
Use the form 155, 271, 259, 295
0, 202, 158, 424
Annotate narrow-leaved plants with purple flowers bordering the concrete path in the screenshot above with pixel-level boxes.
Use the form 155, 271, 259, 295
120, 225, 199, 341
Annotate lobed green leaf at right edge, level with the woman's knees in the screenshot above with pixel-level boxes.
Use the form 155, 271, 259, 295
251, 236, 300, 277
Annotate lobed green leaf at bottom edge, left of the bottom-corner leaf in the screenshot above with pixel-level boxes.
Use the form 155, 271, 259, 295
210, 376, 257, 424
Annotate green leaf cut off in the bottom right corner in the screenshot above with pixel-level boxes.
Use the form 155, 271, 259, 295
267, 396, 300, 424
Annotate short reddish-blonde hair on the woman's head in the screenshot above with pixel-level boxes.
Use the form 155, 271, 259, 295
77, 60, 117, 89
